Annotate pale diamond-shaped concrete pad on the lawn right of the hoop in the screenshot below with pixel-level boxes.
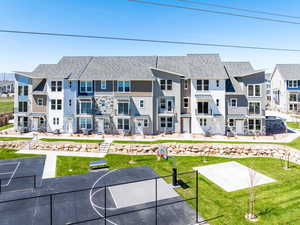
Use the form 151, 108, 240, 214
193, 162, 276, 192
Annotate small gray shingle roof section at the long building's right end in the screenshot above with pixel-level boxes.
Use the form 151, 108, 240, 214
223, 62, 255, 77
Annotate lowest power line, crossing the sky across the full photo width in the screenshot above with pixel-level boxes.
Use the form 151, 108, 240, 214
0, 29, 300, 52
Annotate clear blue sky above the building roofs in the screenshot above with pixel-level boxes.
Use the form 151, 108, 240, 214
0, 0, 300, 72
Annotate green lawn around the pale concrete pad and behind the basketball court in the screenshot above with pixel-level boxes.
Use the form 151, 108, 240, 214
57, 155, 300, 225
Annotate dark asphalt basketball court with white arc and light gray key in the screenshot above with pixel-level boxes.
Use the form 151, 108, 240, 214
0, 158, 202, 225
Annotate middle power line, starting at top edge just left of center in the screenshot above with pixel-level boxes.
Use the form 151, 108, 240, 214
128, 0, 300, 25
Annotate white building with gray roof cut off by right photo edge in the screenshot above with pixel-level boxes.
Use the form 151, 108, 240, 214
271, 64, 300, 113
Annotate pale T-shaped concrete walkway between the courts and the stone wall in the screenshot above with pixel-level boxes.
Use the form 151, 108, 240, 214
18, 150, 106, 179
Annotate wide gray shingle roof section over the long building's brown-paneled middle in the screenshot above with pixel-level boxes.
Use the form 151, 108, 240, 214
79, 56, 157, 80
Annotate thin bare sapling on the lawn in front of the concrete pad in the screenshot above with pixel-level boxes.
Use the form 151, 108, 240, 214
246, 168, 257, 221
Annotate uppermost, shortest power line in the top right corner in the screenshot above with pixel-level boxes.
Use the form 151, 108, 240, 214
176, 0, 300, 19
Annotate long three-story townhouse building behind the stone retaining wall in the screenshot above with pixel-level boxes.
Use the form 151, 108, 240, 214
15, 54, 264, 135
